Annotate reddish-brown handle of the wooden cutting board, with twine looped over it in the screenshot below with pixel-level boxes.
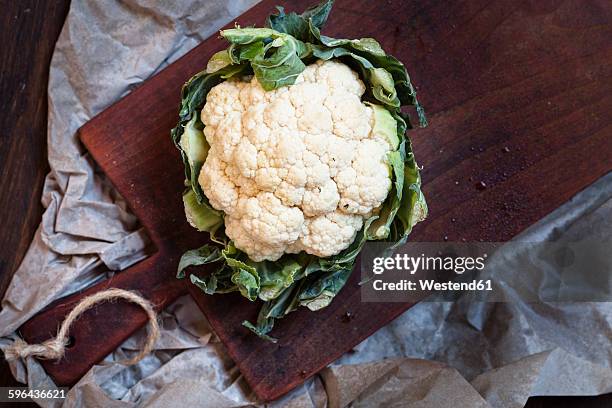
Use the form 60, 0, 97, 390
19, 252, 187, 386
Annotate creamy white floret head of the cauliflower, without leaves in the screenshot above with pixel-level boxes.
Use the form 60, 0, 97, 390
198, 60, 397, 262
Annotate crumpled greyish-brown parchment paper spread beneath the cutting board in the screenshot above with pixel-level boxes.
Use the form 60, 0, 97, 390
0, 0, 612, 408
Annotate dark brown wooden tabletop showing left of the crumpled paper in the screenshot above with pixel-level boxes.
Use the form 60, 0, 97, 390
0, 0, 70, 398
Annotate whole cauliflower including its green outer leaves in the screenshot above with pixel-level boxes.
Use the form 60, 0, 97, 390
170, 0, 427, 341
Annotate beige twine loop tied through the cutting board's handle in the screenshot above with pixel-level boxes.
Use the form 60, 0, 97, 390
4, 288, 159, 365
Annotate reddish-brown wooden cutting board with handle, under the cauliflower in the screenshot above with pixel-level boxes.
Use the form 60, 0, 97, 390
16, 0, 612, 400
